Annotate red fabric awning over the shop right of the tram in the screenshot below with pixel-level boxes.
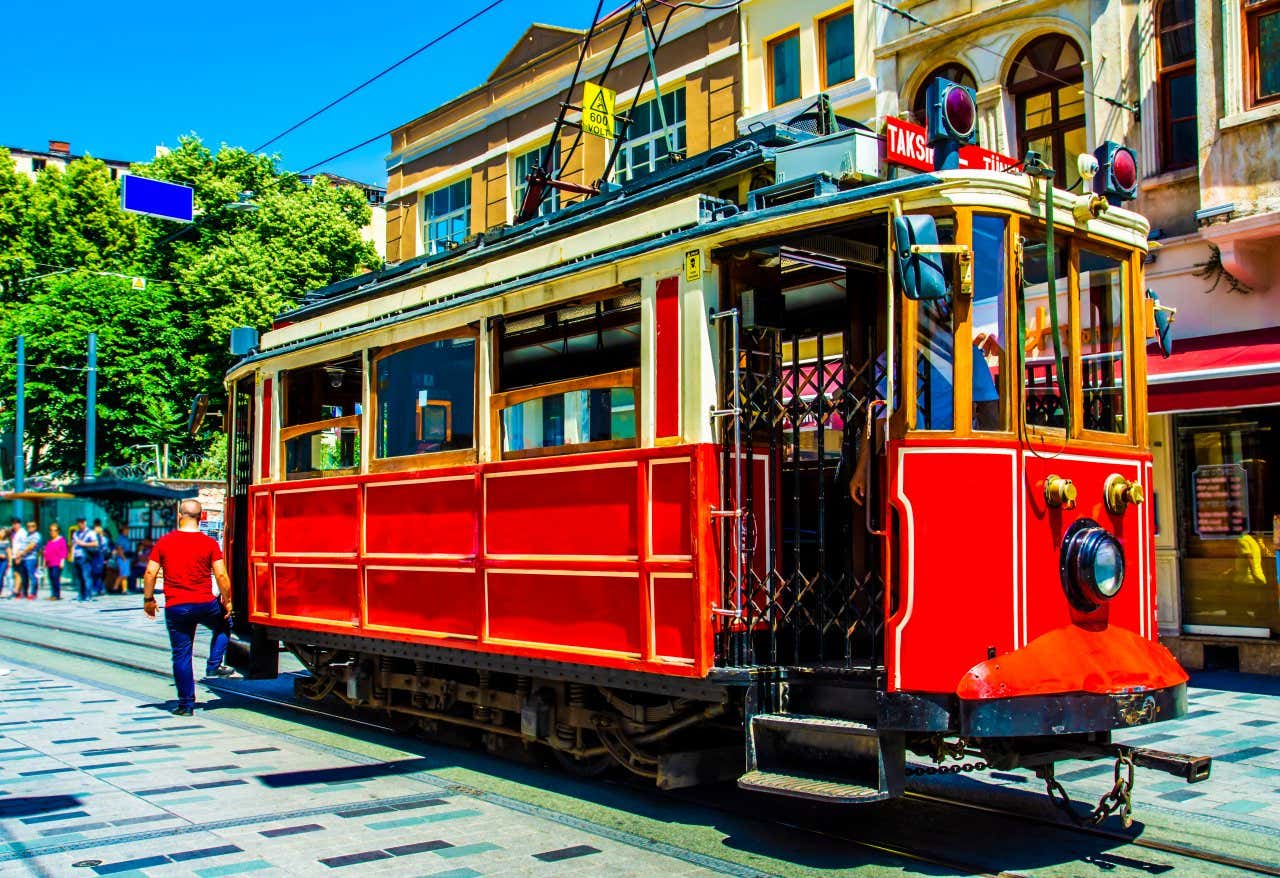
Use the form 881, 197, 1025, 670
1147, 324, 1280, 415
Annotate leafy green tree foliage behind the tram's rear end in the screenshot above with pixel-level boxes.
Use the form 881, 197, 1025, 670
0, 137, 378, 472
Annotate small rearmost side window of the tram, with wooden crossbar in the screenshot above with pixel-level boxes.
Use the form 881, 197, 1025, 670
280, 355, 364, 479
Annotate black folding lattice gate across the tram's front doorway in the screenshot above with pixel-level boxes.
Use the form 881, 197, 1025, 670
714, 318, 884, 673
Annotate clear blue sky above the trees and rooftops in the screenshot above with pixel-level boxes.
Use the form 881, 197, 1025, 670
0, 0, 604, 184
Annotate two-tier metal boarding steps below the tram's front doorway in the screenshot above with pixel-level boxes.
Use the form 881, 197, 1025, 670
737, 713, 906, 802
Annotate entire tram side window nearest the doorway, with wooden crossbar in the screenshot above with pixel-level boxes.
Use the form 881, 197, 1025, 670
492, 291, 640, 459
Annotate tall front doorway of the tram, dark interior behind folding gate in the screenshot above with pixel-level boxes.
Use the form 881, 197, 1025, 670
721, 235, 884, 668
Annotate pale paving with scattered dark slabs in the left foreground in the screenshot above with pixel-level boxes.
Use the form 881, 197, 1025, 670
0, 659, 737, 878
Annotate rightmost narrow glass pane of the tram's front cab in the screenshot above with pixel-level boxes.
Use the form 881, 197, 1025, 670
1080, 248, 1129, 433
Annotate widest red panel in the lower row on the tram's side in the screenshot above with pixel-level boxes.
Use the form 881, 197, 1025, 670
488, 570, 644, 654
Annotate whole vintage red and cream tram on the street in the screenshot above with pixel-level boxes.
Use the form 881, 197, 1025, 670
215, 90, 1207, 801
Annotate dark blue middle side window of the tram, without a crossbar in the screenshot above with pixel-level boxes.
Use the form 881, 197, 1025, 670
376, 338, 476, 457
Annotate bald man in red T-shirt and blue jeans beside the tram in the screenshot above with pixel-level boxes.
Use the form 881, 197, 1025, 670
142, 500, 238, 717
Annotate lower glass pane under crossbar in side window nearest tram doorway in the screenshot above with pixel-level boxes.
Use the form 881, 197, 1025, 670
502, 388, 636, 452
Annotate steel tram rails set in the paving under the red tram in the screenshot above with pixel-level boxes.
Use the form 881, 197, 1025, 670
0, 614, 1280, 878
